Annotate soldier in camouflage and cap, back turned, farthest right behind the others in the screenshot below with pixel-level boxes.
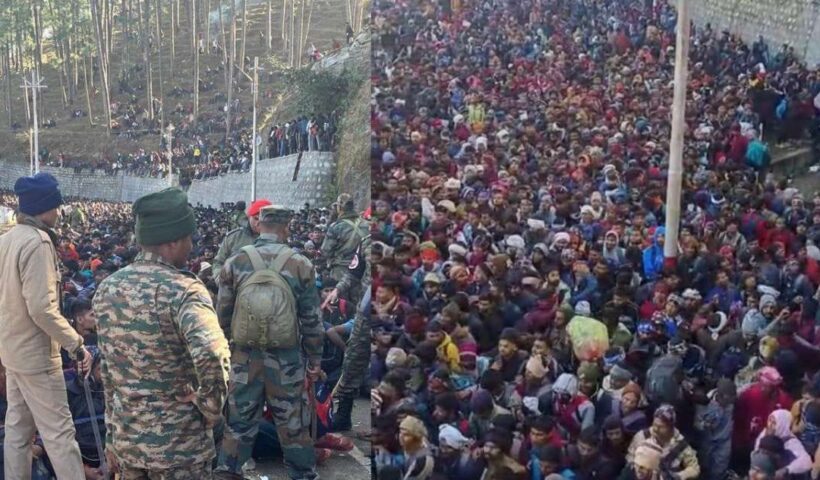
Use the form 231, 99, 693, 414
321, 194, 370, 286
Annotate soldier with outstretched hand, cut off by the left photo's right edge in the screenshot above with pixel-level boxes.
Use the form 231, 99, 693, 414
327, 235, 371, 432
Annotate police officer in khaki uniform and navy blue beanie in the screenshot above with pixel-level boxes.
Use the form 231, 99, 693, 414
0, 173, 91, 480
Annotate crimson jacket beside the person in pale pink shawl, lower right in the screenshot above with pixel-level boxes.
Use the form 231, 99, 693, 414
732, 383, 792, 449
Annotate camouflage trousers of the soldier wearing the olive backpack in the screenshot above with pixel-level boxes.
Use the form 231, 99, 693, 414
216, 347, 317, 480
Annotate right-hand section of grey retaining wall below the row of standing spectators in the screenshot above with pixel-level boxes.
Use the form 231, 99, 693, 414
188, 152, 335, 209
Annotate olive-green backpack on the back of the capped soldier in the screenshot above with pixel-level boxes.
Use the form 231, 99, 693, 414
231, 245, 299, 350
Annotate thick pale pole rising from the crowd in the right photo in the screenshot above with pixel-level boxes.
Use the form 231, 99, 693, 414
663, 0, 689, 265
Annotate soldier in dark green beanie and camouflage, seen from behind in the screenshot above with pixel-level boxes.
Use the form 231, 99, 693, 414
94, 188, 230, 480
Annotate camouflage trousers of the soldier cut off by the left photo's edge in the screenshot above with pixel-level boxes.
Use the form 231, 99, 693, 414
336, 288, 371, 399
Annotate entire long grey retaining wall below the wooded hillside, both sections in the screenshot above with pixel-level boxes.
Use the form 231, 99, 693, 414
0, 152, 335, 208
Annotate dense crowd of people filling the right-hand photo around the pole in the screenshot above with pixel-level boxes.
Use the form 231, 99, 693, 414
371, 0, 820, 480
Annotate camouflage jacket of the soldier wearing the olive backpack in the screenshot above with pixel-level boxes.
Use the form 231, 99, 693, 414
216, 233, 325, 364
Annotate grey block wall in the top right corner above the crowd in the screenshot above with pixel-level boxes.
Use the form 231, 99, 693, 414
689, 0, 820, 66
